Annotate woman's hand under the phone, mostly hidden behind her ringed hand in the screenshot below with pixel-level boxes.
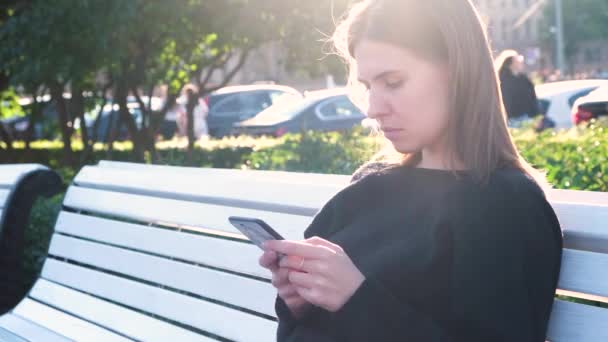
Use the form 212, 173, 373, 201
260, 251, 312, 318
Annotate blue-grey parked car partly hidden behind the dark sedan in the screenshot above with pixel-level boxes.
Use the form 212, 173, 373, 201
205, 85, 302, 137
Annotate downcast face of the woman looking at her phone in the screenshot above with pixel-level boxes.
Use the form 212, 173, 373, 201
354, 40, 450, 159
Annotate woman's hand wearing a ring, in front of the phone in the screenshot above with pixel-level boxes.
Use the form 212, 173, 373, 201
264, 236, 365, 312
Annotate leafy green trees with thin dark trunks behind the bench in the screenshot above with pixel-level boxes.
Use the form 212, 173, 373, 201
0, 0, 348, 163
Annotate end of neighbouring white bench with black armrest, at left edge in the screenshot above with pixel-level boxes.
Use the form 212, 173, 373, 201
0, 164, 63, 313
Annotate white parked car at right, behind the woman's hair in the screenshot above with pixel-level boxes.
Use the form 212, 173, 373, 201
535, 80, 608, 128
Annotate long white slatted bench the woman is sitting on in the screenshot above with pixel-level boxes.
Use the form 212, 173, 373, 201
0, 162, 608, 342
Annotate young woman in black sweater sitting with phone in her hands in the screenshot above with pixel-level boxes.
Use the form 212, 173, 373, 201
260, 0, 562, 342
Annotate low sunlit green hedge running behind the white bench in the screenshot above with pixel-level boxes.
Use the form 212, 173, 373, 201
8, 123, 608, 191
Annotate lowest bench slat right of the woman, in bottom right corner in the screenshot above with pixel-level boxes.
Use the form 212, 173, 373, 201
547, 299, 608, 342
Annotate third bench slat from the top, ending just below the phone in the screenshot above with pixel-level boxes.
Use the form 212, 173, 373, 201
55, 211, 270, 279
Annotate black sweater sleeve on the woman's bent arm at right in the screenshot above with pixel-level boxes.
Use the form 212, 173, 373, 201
332, 175, 561, 342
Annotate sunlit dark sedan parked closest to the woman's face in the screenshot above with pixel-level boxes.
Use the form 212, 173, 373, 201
233, 89, 365, 137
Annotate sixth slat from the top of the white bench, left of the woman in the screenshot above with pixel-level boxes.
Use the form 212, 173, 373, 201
31, 278, 213, 341
